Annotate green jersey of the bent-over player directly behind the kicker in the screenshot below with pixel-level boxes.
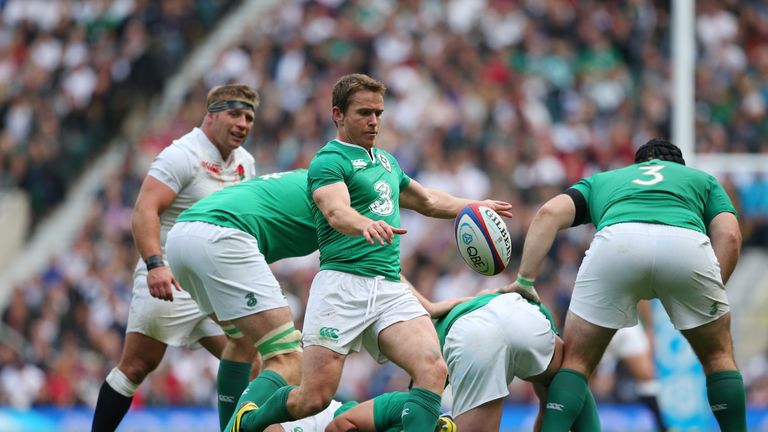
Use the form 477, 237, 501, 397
176, 169, 317, 263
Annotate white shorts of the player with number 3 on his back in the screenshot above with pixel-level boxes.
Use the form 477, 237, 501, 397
569, 223, 730, 330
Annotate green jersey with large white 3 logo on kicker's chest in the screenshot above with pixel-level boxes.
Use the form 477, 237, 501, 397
307, 140, 411, 281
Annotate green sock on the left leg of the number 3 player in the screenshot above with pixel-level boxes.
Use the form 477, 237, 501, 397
541, 369, 600, 432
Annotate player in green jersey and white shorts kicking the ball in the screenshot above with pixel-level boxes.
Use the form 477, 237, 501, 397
234, 74, 511, 432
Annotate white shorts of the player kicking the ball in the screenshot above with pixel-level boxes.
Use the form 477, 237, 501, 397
302, 270, 428, 363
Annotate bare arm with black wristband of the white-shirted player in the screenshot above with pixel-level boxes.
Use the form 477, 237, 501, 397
131, 176, 181, 301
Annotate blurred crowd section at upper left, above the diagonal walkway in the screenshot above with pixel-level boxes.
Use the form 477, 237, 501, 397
0, 0, 236, 221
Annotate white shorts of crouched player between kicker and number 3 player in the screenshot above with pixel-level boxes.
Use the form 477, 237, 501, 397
443, 293, 555, 417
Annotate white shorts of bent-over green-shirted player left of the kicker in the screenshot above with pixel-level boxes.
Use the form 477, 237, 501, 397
165, 222, 288, 321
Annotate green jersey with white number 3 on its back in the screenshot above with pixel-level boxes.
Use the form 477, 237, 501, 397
571, 159, 736, 234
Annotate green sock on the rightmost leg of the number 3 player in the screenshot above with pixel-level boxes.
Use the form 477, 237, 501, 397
707, 371, 747, 432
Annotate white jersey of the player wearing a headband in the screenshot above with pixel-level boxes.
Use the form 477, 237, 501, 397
147, 127, 256, 248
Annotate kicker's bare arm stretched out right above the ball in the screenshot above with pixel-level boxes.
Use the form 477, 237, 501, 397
400, 180, 512, 219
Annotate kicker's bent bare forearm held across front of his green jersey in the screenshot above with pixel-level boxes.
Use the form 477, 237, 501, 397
312, 182, 408, 245
